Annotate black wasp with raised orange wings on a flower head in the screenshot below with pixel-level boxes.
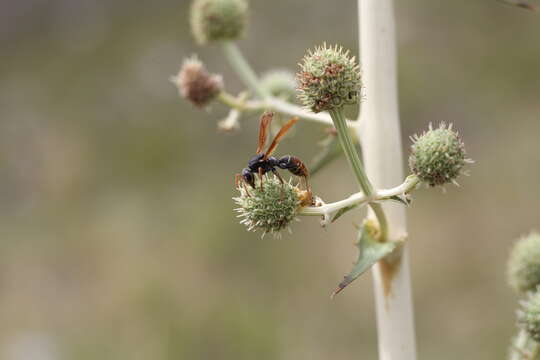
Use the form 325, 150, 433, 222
235, 112, 312, 201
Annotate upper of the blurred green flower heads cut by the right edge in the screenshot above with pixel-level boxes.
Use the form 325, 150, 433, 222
508, 232, 540, 292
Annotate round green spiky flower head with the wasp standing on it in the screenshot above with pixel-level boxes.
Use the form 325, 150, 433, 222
233, 176, 306, 237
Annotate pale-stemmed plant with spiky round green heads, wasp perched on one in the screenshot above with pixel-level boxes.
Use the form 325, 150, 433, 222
176, 0, 471, 360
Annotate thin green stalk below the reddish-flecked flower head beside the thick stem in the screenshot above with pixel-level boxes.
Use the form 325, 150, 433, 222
329, 108, 388, 241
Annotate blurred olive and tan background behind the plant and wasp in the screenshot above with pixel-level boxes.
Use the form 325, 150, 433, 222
0, 0, 540, 360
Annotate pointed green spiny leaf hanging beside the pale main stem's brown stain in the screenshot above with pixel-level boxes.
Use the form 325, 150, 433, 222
331, 221, 399, 298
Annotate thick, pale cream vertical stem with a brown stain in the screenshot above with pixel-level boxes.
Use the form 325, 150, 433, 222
358, 0, 416, 360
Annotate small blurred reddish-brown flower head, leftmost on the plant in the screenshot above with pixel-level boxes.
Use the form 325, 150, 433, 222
171, 55, 223, 107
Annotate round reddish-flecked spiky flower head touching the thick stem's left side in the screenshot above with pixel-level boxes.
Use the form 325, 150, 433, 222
296, 43, 362, 113
